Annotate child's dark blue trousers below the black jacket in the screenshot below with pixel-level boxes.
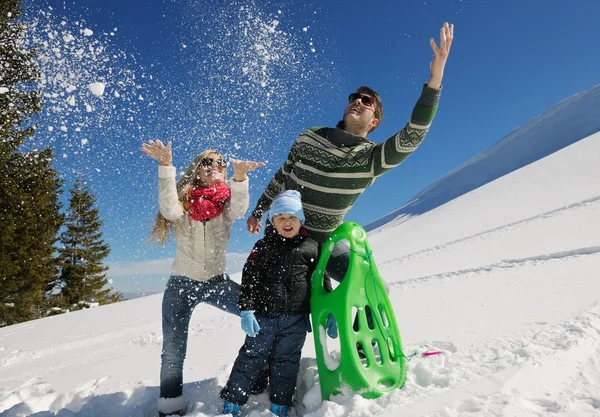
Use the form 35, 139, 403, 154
221, 315, 309, 406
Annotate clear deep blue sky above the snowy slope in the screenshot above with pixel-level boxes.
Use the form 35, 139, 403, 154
24, 0, 600, 291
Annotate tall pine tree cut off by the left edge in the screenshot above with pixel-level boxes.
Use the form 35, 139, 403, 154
0, 0, 62, 326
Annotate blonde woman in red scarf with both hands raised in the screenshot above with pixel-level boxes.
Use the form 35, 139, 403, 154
141, 140, 264, 416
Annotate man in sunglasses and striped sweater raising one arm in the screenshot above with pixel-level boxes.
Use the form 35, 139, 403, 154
247, 23, 454, 281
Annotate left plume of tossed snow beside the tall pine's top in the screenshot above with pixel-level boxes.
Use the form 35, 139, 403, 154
21, 5, 144, 158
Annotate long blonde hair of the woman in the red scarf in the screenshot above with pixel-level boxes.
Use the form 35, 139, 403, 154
148, 149, 227, 246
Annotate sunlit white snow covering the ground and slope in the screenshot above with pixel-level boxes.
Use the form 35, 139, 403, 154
0, 102, 600, 417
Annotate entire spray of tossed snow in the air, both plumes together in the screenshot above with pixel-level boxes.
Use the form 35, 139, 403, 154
22, 0, 328, 188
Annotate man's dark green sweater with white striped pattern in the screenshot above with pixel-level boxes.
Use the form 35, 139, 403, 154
252, 86, 440, 243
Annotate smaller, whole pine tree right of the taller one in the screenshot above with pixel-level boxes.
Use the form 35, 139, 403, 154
53, 179, 123, 308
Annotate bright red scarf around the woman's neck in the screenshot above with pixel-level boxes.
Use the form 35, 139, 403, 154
188, 182, 231, 222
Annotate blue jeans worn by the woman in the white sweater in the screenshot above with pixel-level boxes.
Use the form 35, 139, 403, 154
160, 274, 240, 398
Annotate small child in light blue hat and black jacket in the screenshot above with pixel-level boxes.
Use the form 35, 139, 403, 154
221, 190, 319, 417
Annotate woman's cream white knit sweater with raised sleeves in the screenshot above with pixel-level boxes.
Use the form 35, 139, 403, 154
158, 166, 250, 281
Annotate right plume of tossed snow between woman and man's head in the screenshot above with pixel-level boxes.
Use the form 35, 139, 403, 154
171, 0, 329, 158
